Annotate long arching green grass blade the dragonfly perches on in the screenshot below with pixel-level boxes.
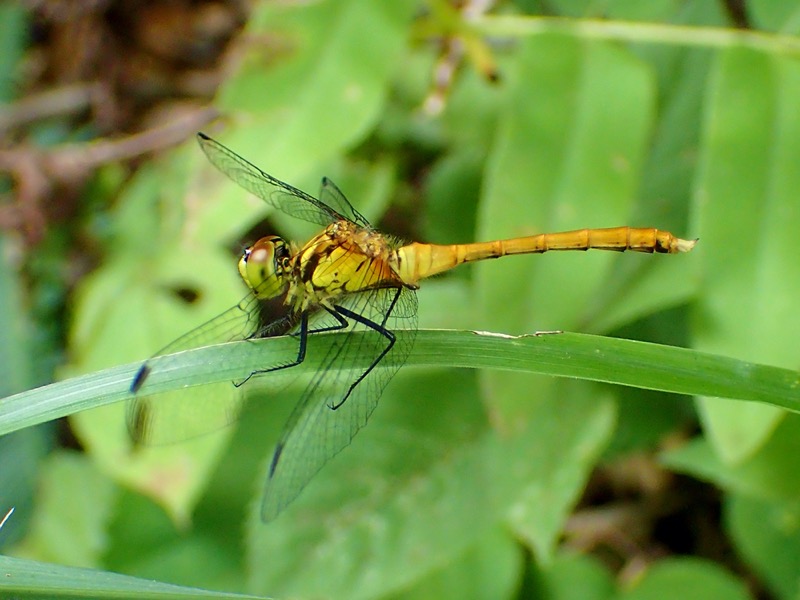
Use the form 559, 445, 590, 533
0, 330, 800, 435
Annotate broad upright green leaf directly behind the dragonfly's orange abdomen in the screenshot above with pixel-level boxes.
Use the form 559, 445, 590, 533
476, 31, 653, 560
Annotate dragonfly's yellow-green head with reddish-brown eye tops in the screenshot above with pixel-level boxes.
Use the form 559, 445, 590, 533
239, 235, 291, 299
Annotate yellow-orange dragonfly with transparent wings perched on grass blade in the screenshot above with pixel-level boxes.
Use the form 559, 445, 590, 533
127, 133, 697, 522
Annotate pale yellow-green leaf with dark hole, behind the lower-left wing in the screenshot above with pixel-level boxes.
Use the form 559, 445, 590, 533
66, 243, 244, 523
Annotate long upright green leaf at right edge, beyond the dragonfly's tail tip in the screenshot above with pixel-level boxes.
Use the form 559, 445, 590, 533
695, 49, 800, 462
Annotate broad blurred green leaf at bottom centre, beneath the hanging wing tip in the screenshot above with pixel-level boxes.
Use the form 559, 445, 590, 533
249, 372, 501, 598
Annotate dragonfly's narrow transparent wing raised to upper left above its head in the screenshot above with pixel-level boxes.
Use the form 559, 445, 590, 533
197, 133, 368, 226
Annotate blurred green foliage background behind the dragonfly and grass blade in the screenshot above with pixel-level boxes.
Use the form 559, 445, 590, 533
0, 0, 800, 598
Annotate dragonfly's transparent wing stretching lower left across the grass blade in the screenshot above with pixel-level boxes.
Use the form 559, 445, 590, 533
126, 293, 296, 446
